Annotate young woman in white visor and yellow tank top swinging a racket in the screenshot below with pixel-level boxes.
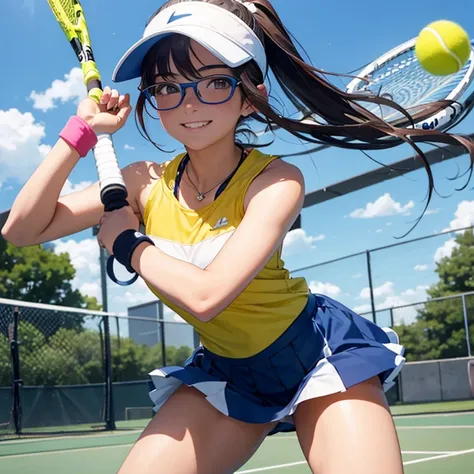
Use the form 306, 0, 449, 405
3, 0, 474, 474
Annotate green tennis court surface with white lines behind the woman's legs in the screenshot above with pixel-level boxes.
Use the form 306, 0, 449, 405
0, 406, 474, 474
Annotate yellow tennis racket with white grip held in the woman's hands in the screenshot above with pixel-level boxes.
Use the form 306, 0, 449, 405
48, 0, 138, 286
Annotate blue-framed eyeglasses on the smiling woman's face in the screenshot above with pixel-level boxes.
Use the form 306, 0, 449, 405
137, 74, 241, 111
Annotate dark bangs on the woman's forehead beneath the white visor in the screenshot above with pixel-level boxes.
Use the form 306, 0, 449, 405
142, 33, 211, 87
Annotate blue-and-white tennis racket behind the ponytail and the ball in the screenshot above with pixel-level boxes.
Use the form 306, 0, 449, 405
347, 38, 474, 131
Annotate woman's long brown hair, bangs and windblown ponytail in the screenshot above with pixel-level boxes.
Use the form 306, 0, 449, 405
136, 0, 474, 225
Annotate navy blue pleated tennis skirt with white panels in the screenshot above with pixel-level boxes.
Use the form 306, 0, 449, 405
150, 294, 405, 434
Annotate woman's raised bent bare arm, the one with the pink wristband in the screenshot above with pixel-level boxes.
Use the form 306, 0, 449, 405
2, 88, 136, 247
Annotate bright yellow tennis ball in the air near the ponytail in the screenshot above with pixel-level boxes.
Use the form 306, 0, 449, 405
415, 20, 471, 76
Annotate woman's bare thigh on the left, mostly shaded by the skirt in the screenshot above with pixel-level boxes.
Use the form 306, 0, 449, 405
118, 386, 272, 474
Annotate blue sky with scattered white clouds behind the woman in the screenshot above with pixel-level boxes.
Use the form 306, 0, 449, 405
0, 0, 474, 336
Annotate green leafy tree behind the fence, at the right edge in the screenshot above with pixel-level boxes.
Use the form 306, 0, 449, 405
396, 231, 474, 360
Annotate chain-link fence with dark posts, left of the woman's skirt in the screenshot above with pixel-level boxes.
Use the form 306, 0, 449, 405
0, 299, 194, 439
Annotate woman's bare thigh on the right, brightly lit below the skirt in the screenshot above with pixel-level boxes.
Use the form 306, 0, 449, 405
295, 377, 403, 474
